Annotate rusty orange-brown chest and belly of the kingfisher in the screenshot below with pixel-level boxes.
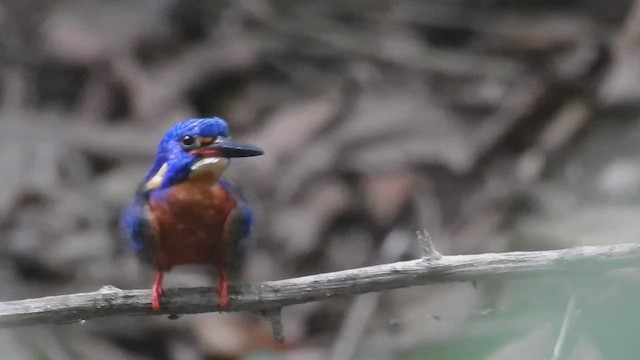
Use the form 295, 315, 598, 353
149, 180, 236, 269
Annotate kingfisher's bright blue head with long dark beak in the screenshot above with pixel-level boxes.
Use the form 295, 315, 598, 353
144, 117, 263, 190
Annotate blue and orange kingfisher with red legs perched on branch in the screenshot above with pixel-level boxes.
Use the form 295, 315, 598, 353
120, 117, 263, 311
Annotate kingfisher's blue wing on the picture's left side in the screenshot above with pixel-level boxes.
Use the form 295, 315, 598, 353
120, 186, 154, 262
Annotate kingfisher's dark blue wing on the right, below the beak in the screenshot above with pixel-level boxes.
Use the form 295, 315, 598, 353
219, 180, 253, 272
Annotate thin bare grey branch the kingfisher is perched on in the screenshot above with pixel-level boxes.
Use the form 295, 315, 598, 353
0, 244, 640, 327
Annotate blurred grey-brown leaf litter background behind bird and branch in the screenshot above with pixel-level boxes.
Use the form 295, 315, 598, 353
0, 0, 640, 360
